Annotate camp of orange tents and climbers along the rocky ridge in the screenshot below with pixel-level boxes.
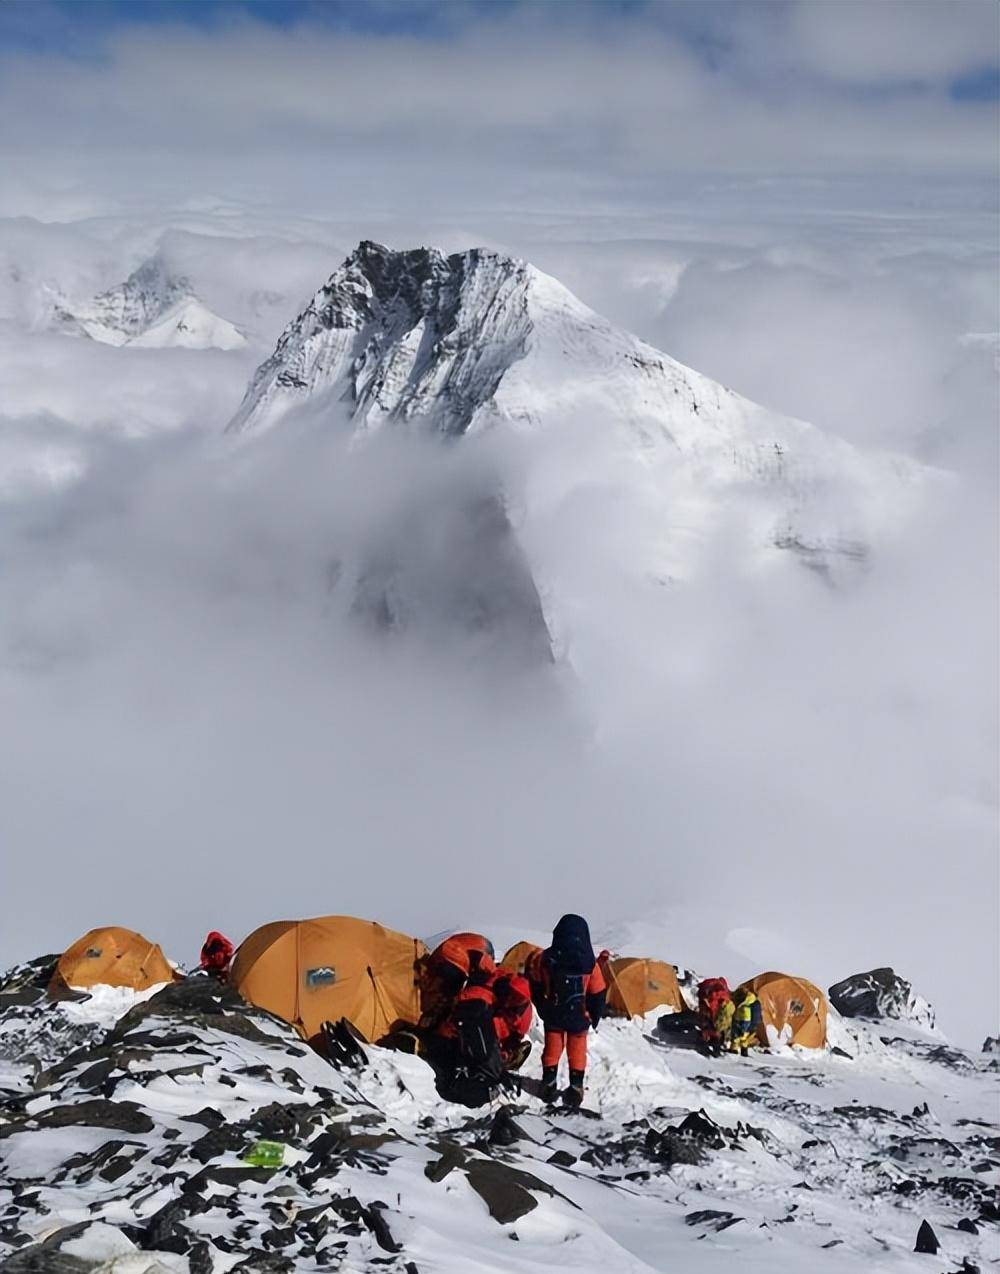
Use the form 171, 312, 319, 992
42, 913, 827, 1107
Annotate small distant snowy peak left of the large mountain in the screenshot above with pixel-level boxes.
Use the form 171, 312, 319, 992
51, 255, 246, 349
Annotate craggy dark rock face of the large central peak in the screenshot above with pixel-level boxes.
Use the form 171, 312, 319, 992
229, 240, 537, 434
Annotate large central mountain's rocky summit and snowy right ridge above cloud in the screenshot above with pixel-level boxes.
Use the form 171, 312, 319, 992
228, 241, 930, 573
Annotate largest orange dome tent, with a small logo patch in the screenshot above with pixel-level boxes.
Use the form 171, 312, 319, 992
229, 916, 427, 1043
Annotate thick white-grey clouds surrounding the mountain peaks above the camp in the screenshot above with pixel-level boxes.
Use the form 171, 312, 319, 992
0, 4, 1000, 1042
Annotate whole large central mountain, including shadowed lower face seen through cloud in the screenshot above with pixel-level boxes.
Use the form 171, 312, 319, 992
219, 240, 935, 660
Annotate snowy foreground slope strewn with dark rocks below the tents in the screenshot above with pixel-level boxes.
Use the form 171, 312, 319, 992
0, 976, 1000, 1274
